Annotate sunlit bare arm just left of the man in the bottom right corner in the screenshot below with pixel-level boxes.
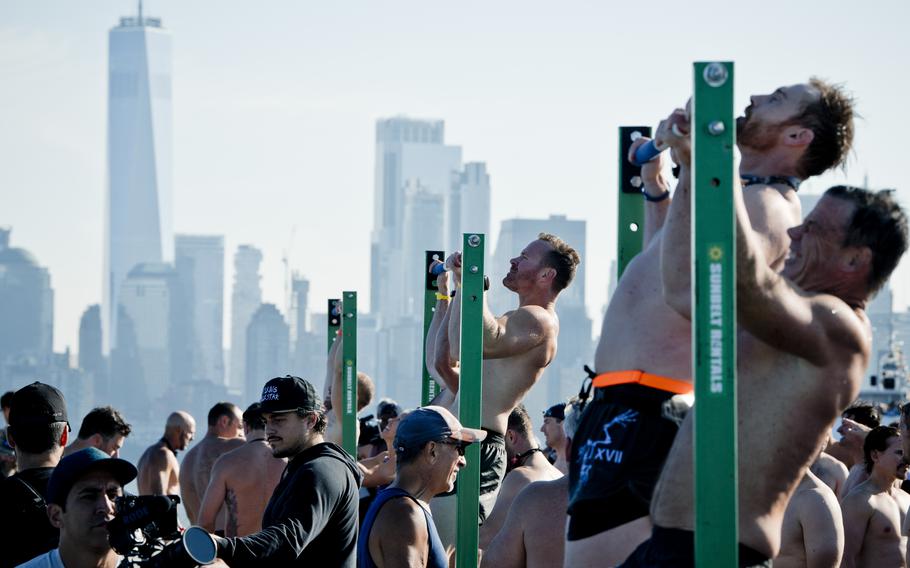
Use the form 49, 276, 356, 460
799, 490, 844, 568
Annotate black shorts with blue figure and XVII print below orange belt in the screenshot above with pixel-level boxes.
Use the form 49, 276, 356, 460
567, 383, 688, 541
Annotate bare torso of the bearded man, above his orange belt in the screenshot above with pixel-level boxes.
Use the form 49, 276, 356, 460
594, 186, 800, 381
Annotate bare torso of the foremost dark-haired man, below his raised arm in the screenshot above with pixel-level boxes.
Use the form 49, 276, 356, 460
651, 312, 871, 558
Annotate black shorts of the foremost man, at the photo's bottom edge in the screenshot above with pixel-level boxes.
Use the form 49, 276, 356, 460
618, 526, 771, 568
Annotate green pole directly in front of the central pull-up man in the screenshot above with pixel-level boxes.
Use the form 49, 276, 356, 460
449, 233, 484, 568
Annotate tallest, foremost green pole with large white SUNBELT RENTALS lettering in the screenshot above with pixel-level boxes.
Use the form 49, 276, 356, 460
691, 62, 739, 568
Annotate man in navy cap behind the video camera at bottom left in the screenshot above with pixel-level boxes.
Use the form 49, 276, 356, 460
20, 448, 137, 568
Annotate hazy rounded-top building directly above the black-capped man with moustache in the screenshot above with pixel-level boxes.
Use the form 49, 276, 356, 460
246, 304, 291, 401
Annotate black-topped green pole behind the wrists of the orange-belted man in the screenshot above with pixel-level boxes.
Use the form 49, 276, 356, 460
616, 126, 651, 280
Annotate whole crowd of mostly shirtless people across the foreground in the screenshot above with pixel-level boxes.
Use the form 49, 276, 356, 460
0, 72, 910, 568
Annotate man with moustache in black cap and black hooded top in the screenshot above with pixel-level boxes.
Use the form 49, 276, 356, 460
216, 376, 362, 568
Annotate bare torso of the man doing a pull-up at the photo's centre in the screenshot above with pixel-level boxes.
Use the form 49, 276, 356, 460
481, 306, 559, 434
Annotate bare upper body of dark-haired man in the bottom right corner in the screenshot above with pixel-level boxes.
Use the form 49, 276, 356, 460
843, 480, 910, 568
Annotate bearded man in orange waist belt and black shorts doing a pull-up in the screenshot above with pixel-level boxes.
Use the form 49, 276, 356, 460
566, 79, 853, 566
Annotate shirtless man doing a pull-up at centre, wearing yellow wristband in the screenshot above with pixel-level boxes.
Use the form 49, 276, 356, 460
427, 233, 581, 532
